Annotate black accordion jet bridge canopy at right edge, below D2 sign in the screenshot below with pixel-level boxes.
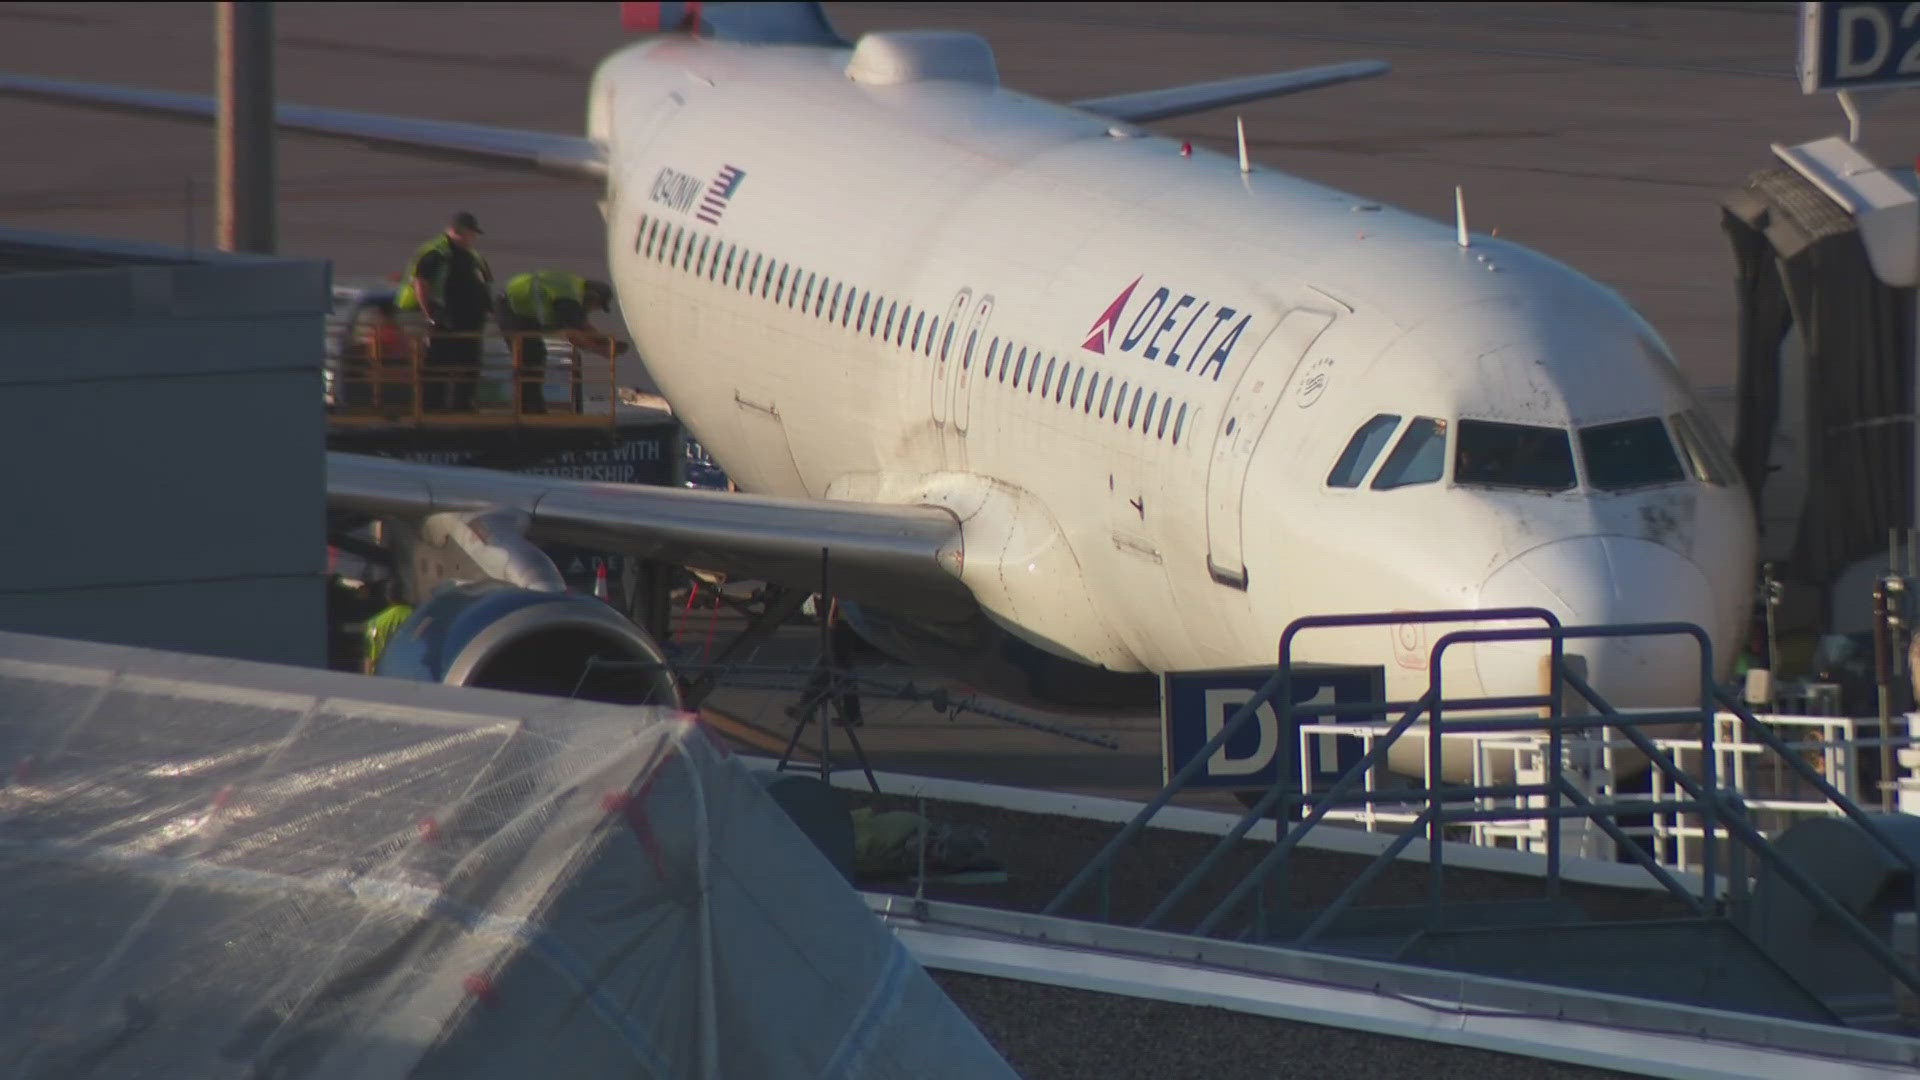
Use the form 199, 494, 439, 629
1720, 136, 1920, 628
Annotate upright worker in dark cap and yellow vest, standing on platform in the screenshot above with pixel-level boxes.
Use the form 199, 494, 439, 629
399, 209, 493, 413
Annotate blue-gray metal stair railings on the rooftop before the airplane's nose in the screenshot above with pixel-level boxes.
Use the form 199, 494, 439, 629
1043, 609, 1920, 994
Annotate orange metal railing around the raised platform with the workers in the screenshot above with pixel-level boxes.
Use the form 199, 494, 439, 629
328, 329, 618, 427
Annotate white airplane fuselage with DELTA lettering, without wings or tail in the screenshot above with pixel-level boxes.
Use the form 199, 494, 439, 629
589, 40, 1755, 764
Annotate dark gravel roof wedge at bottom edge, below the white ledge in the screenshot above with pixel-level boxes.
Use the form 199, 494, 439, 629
933, 970, 1636, 1080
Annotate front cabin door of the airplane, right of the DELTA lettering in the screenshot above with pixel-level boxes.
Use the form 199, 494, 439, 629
1206, 307, 1332, 588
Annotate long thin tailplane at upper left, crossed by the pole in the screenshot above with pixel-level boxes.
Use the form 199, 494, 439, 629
0, 73, 607, 181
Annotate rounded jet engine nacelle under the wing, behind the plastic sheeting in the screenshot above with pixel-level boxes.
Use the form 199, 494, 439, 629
378, 580, 680, 707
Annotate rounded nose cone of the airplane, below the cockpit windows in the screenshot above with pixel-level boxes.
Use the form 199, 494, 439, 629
1475, 536, 1715, 707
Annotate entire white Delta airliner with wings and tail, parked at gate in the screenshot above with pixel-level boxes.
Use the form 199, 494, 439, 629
0, 4, 1755, 774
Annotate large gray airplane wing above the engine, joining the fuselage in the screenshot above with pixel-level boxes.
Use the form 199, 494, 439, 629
326, 452, 973, 617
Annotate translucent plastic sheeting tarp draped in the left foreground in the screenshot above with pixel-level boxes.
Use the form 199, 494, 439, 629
0, 634, 1012, 1078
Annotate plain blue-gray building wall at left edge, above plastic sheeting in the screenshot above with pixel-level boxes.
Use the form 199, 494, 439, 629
0, 231, 330, 665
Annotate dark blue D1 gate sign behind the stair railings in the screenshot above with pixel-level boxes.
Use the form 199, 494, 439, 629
1160, 665, 1386, 792
